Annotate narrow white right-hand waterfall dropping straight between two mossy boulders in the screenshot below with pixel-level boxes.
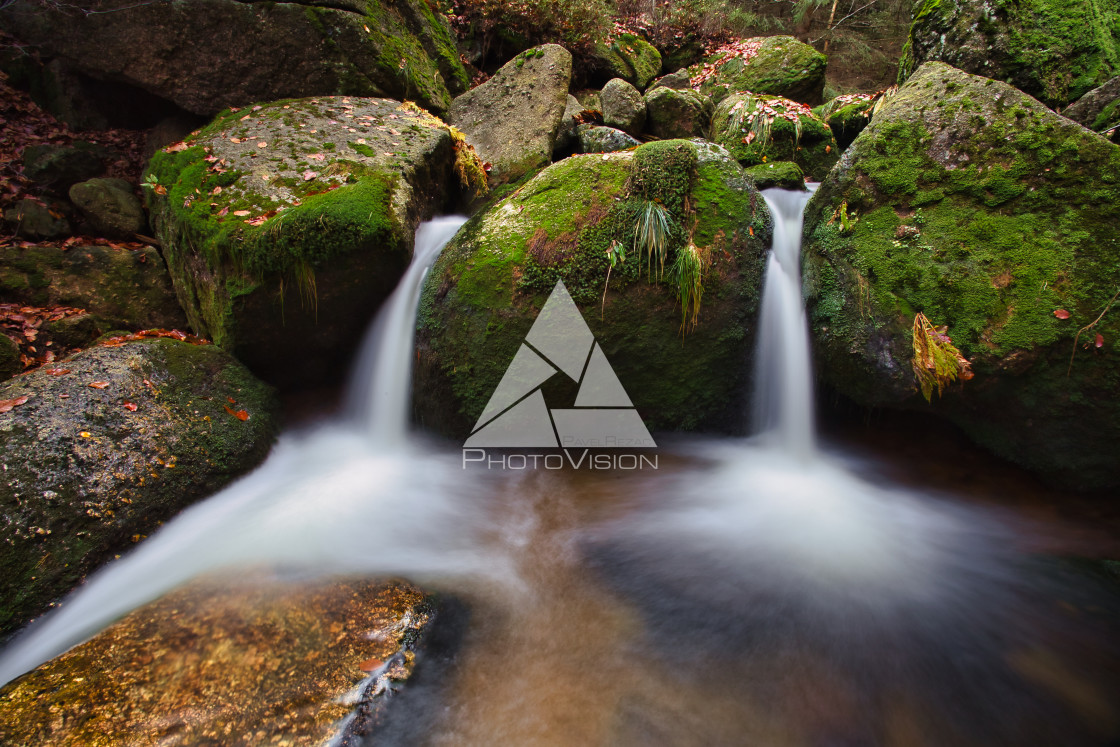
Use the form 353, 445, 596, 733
754, 185, 815, 459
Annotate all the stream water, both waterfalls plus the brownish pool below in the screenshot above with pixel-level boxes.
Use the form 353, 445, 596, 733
0, 201, 1120, 747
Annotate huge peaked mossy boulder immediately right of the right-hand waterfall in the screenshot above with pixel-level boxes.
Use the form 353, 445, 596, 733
804, 63, 1120, 486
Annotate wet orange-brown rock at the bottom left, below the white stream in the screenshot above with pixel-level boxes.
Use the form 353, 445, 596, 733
0, 577, 432, 747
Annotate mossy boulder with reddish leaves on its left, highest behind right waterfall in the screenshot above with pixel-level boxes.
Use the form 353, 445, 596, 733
689, 36, 828, 106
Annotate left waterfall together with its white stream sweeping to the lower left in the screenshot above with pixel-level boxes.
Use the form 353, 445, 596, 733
0, 212, 513, 683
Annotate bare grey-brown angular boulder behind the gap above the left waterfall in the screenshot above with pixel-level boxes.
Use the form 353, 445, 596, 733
448, 44, 571, 184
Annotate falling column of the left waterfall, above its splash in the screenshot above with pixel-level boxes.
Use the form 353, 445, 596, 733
346, 215, 467, 448
